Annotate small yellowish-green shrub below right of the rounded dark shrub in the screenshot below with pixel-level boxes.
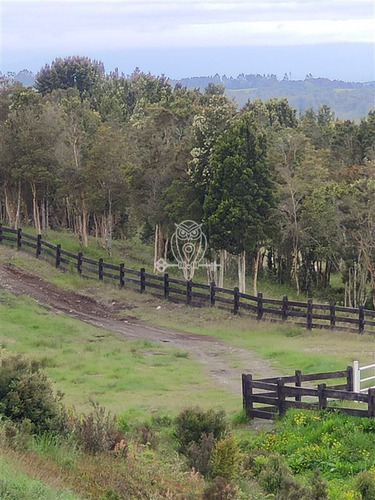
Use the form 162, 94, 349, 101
211, 434, 241, 481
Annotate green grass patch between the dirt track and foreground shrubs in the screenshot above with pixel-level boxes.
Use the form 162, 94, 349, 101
0, 291, 240, 415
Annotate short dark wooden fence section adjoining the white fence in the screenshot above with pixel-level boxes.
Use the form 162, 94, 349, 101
242, 366, 375, 419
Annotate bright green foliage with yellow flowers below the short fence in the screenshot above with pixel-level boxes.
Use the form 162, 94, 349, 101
245, 410, 375, 479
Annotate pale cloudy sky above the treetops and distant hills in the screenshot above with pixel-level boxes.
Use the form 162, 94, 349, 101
0, 0, 375, 81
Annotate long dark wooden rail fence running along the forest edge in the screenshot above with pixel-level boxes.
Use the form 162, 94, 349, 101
0, 224, 375, 334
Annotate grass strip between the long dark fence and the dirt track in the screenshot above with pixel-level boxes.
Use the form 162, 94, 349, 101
0, 241, 375, 390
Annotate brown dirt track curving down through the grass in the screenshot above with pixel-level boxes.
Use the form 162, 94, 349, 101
0, 264, 278, 394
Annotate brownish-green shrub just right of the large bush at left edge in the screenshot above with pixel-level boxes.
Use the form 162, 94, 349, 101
68, 401, 124, 453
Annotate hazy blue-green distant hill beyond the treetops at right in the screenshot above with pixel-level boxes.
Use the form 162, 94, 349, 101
174, 74, 375, 120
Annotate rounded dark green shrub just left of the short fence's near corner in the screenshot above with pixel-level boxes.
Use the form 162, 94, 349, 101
175, 407, 228, 454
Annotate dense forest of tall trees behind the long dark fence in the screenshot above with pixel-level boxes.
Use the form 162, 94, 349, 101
0, 57, 375, 308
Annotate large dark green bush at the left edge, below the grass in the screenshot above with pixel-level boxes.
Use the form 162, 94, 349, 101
0, 354, 65, 432
